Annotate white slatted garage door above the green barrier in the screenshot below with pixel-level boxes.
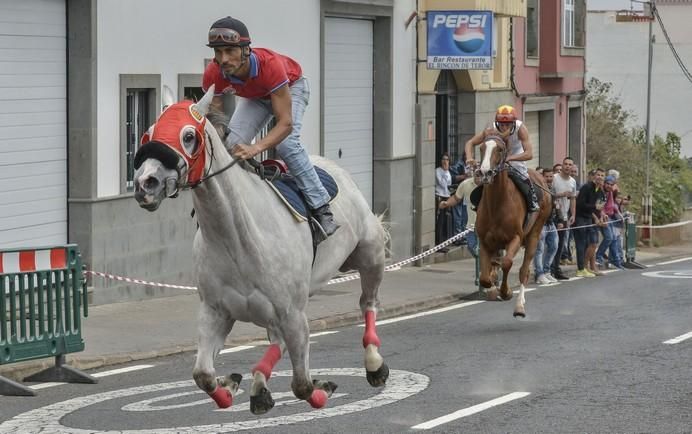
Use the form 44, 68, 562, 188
0, 0, 67, 249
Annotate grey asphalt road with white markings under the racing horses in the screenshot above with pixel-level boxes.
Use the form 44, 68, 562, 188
0, 261, 692, 433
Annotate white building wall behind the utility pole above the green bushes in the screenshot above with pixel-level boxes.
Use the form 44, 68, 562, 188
586, 4, 692, 156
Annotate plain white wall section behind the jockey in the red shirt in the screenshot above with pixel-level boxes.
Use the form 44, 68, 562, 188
96, 0, 322, 197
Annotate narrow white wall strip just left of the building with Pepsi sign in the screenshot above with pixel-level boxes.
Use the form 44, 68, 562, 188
392, 0, 416, 157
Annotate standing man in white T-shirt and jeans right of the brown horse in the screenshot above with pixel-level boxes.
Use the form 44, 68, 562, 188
550, 157, 577, 280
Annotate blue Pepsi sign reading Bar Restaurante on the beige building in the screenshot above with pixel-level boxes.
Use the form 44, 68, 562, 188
427, 11, 493, 69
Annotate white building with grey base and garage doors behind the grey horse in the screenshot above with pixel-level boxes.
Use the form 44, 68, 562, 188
0, 0, 415, 303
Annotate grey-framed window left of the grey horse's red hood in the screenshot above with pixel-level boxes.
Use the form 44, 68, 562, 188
120, 75, 161, 193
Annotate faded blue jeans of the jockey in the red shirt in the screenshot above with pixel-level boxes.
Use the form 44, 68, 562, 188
226, 77, 329, 209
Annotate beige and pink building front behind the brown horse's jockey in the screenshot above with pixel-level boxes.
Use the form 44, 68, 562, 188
415, 0, 586, 256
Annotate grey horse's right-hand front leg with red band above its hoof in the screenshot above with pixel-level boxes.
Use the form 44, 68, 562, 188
280, 310, 336, 408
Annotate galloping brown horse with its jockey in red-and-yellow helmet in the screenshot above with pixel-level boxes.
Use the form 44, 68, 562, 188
465, 105, 550, 316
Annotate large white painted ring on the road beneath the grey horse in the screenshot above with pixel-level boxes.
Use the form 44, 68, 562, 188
0, 368, 430, 434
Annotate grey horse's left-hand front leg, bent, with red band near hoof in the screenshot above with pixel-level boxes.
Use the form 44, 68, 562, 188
192, 303, 243, 408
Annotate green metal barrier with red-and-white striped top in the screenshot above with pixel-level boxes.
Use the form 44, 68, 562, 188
0, 245, 95, 395
